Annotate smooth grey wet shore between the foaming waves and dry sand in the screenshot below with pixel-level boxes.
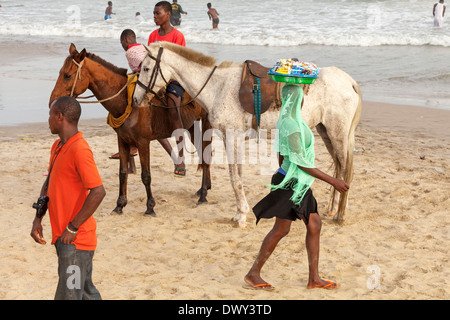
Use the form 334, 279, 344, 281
0, 36, 450, 126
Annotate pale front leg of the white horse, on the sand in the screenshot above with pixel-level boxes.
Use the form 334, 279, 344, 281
223, 134, 250, 228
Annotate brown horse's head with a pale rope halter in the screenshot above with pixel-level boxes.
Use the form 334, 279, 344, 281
49, 43, 89, 106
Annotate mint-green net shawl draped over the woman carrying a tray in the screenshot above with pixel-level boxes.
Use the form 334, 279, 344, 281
270, 84, 315, 205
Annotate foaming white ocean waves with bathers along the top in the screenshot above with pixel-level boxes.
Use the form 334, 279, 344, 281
0, 0, 450, 47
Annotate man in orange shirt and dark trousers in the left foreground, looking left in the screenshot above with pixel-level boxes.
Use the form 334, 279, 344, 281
31, 97, 106, 300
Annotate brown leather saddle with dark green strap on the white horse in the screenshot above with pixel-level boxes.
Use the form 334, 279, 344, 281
239, 60, 282, 127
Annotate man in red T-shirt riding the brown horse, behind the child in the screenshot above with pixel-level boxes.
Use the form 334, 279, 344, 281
148, 1, 186, 176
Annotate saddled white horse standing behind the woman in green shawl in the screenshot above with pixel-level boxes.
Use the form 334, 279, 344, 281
134, 42, 362, 226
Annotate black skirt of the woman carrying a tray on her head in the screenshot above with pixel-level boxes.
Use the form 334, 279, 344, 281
253, 172, 318, 224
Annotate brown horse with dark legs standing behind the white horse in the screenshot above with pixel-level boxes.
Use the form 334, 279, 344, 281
49, 44, 211, 216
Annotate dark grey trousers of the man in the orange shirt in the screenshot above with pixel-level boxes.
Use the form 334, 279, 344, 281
55, 239, 102, 300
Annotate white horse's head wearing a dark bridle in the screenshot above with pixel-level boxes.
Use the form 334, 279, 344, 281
133, 43, 171, 105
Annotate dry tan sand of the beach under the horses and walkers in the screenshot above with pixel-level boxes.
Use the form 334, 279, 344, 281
0, 98, 450, 300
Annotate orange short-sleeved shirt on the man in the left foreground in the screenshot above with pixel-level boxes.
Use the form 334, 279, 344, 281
47, 132, 103, 251
